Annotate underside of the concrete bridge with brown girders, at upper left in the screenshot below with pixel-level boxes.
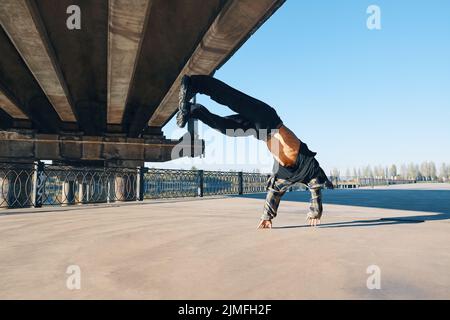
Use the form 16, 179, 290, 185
0, 0, 284, 162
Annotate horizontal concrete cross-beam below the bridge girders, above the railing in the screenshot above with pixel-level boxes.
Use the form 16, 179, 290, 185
0, 131, 204, 162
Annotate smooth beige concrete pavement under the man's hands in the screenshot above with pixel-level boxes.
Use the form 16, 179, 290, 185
0, 184, 450, 299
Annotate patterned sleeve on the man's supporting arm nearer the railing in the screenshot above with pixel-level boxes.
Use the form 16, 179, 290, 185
261, 176, 294, 220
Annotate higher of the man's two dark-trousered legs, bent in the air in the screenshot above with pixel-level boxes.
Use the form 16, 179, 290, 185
187, 75, 282, 130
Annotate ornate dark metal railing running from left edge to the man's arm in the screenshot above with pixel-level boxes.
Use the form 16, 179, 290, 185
0, 162, 268, 208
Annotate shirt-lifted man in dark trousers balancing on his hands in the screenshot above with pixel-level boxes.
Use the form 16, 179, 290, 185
177, 75, 333, 229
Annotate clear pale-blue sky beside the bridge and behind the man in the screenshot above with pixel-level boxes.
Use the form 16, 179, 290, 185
150, 0, 450, 172
